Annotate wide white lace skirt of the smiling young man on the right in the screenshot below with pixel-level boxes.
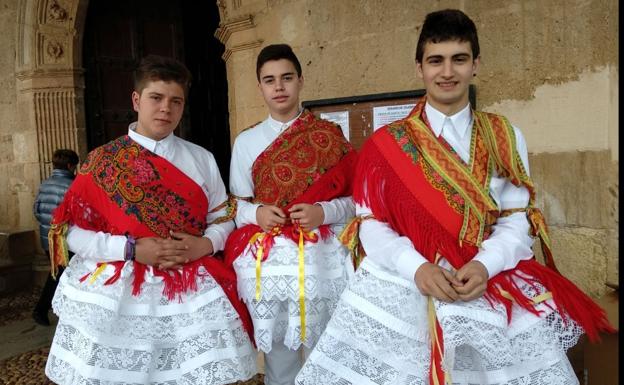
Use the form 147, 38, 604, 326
296, 259, 582, 385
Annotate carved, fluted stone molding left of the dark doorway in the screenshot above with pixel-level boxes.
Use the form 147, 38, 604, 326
15, 0, 89, 180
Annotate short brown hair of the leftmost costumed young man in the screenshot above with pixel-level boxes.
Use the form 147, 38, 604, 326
134, 55, 191, 95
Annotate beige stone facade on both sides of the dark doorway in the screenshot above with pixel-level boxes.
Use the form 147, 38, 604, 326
0, 0, 619, 296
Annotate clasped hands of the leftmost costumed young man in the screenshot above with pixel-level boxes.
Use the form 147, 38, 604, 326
135, 232, 213, 270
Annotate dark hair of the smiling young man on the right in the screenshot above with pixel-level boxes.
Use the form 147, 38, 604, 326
416, 9, 479, 63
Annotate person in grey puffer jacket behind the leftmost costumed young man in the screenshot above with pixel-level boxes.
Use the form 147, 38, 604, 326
32, 149, 79, 326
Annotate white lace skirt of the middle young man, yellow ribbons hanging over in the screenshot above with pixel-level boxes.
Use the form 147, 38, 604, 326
234, 226, 353, 353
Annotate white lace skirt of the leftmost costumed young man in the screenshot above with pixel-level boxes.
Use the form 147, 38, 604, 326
46, 255, 256, 385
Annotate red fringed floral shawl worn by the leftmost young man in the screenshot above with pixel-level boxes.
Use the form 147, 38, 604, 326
49, 136, 253, 340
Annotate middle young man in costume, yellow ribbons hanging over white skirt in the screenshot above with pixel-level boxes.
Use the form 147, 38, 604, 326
225, 44, 356, 385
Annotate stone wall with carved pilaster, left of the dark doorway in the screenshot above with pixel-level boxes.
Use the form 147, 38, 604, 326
0, 0, 88, 237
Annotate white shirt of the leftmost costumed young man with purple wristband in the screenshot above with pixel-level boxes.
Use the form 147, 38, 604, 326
67, 122, 234, 261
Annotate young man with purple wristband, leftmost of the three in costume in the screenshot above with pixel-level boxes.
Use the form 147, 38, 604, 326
46, 56, 256, 385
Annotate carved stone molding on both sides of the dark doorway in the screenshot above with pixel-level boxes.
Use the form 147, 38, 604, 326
15, 0, 267, 180
